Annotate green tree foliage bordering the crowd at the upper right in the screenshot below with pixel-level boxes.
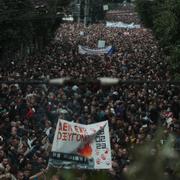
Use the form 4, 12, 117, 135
136, 0, 180, 78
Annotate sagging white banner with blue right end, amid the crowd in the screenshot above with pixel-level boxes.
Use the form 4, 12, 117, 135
78, 45, 112, 55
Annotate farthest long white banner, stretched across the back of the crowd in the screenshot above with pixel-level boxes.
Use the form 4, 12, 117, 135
106, 22, 141, 29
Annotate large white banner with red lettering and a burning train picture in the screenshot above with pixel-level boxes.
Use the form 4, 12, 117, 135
48, 119, 111, 169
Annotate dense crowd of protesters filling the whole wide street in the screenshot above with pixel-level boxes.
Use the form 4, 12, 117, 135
0, 3, 180, 180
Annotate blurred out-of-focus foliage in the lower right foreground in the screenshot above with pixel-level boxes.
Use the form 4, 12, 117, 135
127, 129, 180, 180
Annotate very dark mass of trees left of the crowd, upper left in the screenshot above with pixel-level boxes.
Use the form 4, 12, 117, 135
0, 0, 70, 61
